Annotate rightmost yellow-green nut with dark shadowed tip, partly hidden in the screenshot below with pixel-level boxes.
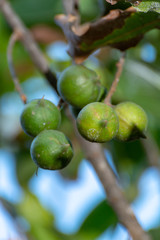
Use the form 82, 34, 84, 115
114, 102, 148, 141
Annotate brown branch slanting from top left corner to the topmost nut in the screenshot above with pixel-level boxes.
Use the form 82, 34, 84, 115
0, 0, 57, 91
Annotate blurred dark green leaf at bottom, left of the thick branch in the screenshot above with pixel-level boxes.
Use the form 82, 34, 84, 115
77, 201, 118, 239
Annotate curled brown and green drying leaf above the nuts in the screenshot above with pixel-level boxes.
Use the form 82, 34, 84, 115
56, 7, 160, 63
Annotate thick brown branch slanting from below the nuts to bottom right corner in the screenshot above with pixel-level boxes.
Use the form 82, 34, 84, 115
67, 111, 151, 240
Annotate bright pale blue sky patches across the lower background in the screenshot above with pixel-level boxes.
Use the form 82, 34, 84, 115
0, 146, 160, 240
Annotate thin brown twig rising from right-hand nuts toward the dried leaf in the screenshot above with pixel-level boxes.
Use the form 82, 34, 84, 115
104, 53, 125, 104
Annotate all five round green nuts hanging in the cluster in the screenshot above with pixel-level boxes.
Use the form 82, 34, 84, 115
21, 65, 147, 170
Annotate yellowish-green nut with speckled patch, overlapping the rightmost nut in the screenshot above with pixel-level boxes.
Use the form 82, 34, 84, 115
77, 102, 118, 142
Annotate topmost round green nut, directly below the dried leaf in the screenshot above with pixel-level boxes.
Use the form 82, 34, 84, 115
57, 65, 106, 109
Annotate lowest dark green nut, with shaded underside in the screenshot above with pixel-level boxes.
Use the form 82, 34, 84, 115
30, 130, 73, 170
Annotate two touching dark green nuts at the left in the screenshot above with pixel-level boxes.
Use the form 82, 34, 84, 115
20, 98, 73, 170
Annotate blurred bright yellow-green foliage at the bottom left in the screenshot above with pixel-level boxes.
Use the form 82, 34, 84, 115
15, 189, 75, 240
